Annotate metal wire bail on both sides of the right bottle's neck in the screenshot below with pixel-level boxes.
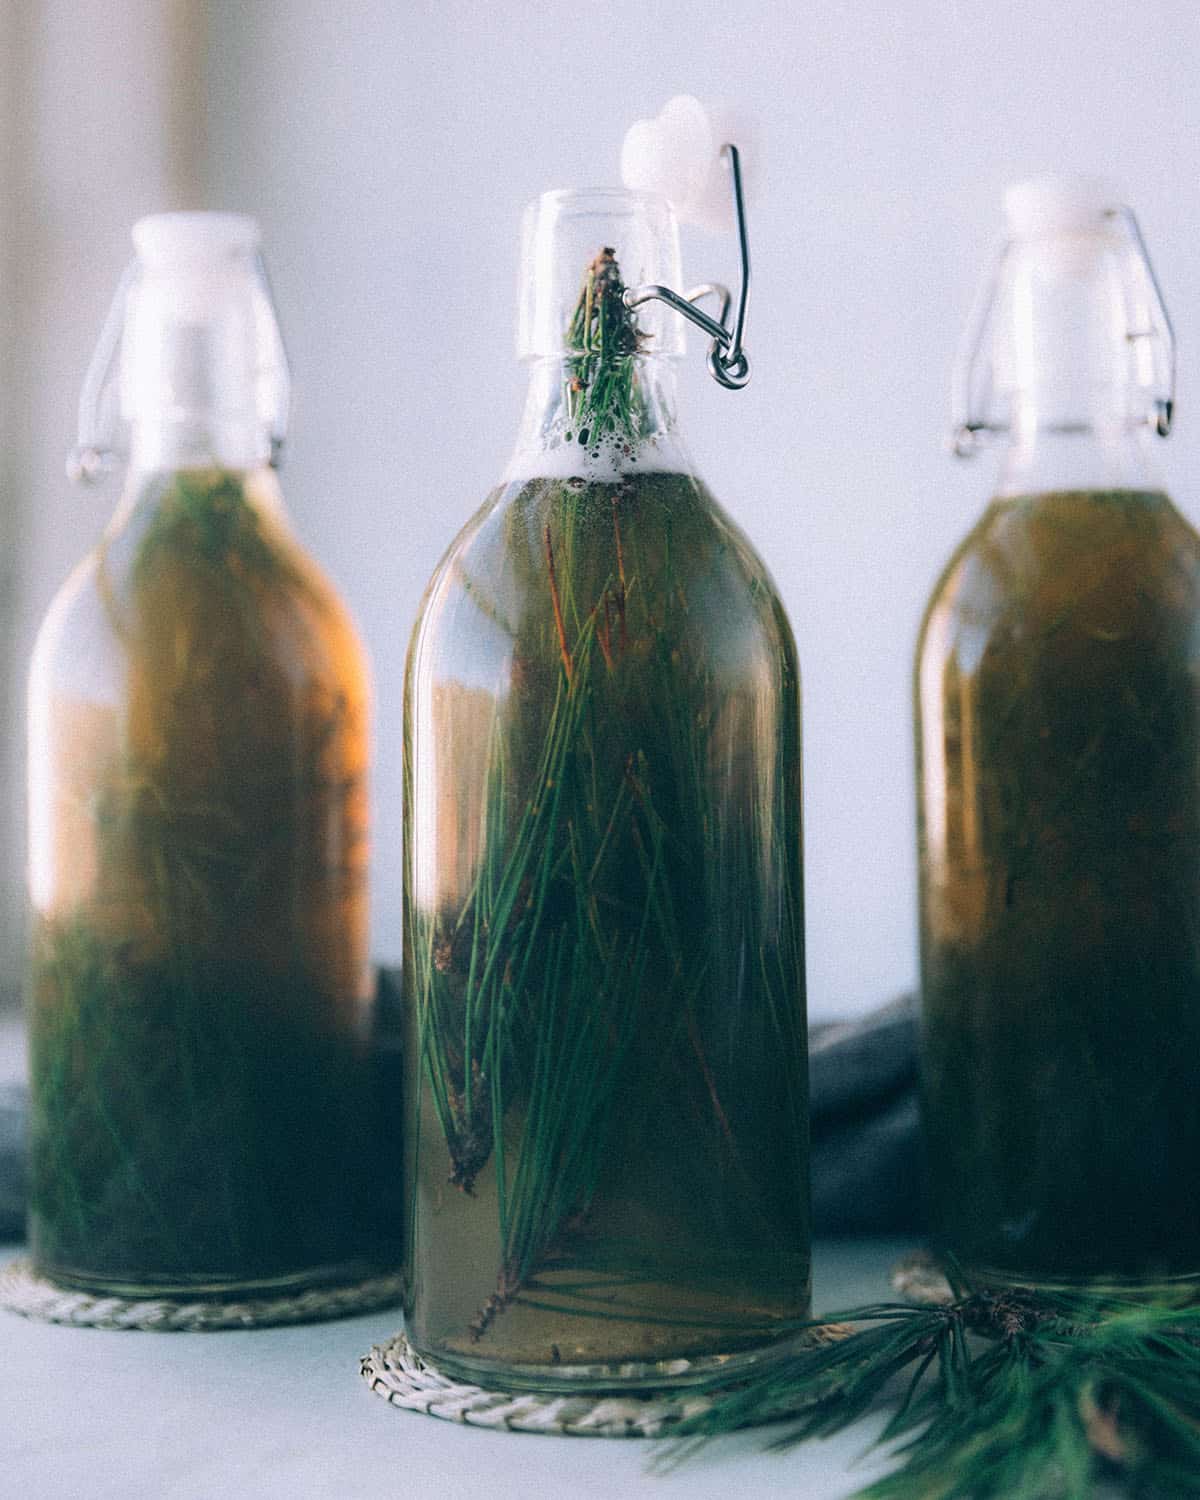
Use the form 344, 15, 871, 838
947, 204, 1176, 459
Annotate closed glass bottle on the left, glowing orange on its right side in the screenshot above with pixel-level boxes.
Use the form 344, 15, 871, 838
29, 215, 390, 1296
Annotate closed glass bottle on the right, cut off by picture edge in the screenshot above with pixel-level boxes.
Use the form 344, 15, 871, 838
915, 180, 1200, 1283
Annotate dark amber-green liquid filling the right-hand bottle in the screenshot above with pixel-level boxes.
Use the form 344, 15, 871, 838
918, 492, 1200, 1280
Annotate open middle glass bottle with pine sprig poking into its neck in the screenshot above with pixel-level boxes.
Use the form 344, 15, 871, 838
405, 192, 810, 1388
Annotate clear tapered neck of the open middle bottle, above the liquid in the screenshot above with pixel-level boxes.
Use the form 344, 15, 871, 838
507, 354, 692, 480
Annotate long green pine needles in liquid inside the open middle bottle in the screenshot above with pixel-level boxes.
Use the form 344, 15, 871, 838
407, 473, 807, 1367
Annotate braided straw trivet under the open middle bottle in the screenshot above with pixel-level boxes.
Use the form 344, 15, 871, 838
362, 1323, 849, 1437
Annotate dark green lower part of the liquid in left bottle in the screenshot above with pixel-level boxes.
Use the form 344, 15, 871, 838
30, 924, 381, 1295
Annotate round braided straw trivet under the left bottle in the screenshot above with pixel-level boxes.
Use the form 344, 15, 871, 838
0, 1259, 402, 1334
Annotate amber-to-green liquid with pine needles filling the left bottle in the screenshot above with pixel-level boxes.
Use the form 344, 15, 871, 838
29, 470, 381, 1295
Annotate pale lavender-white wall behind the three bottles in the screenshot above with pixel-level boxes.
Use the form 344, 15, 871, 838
9, 0, 1200, 1016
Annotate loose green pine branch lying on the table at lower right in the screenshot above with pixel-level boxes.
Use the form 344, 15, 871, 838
668, 1284, 1200, 1500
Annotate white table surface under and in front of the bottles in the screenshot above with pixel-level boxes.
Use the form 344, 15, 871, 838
0, 1241, 911, 1500
